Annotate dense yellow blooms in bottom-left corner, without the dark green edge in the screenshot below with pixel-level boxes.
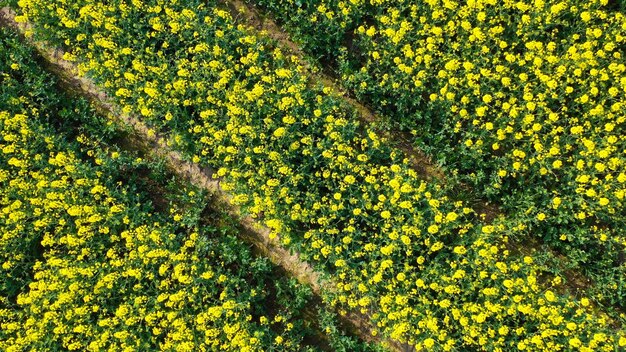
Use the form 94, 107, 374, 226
0, 111, 297, 351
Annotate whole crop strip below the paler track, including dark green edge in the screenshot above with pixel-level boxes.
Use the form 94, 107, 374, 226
0, 29, 368, 351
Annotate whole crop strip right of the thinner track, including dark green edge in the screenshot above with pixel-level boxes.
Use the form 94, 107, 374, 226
244, 0, 626, 307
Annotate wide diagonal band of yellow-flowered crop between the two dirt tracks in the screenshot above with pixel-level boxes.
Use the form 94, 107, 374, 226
11, 0, 626, 350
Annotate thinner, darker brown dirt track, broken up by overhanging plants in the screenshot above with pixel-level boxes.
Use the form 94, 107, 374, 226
219, 0, 616, 302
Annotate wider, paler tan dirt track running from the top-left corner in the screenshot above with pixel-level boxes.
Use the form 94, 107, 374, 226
0, 7, 410, 351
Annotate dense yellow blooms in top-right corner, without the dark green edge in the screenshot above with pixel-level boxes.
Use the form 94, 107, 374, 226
348, 1, 626, 239
